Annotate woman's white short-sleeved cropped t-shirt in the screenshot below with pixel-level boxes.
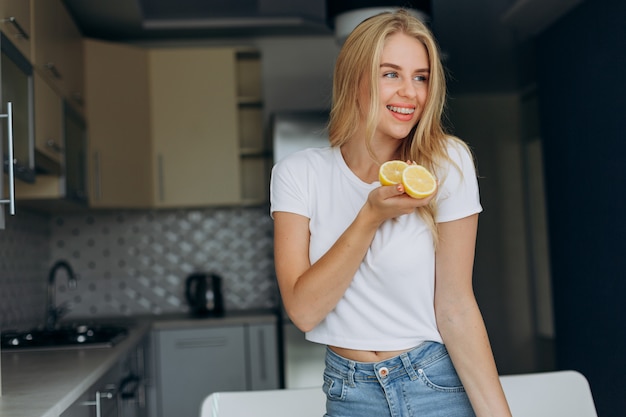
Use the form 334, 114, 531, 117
270, 140, 482, 351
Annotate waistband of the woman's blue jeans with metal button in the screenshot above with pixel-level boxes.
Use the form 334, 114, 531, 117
326, 342, 448, 384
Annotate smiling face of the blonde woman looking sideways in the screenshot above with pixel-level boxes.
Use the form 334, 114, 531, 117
359, 33, 430, 145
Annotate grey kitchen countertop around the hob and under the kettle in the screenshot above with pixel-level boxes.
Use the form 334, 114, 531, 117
0, 312, 277, 417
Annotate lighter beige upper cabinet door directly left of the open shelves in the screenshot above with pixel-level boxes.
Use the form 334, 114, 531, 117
150, 48, 241, 207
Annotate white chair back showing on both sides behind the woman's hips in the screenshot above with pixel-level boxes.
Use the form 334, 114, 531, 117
200, 371, 598, 417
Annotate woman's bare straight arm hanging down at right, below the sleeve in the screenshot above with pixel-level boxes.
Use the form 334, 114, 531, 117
435, 214, 511, 417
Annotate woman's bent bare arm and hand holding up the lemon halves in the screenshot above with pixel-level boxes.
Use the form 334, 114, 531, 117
274, 182, 432, 332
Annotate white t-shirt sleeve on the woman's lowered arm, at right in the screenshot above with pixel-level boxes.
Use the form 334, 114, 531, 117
436, 141, 482, 223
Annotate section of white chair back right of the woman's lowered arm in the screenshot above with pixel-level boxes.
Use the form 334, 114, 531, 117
500, 371, 598, 417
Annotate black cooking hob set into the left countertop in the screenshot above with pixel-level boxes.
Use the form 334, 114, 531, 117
1, 324, 128, 351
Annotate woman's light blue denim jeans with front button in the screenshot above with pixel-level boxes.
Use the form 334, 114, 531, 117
323, 342, 474, 417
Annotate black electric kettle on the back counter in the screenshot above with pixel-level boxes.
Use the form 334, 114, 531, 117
185, 272, 224, 317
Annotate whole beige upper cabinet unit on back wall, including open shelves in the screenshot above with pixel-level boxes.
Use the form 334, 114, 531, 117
85, 40, 268, 208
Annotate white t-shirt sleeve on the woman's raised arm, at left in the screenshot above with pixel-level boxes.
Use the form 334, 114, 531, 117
270, 155, 310, 217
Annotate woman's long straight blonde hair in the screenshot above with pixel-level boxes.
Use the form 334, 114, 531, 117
328, 9, 466, 243
